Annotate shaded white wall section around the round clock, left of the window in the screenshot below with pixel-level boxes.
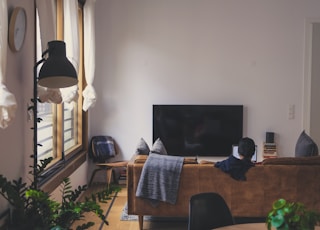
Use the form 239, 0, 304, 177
0, 0, 34, 213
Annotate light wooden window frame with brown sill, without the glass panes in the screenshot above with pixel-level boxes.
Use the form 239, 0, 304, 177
39, 0, 88, 193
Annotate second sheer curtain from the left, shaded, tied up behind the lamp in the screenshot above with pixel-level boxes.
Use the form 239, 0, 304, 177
36, 0, 62, 104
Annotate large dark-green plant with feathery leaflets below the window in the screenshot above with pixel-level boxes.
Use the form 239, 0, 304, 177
0, 158, 120, 230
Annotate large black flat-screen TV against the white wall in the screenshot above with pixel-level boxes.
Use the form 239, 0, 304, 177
153, 105, 243, 156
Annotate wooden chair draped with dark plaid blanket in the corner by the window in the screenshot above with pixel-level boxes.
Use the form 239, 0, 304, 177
89, 136, 128, 186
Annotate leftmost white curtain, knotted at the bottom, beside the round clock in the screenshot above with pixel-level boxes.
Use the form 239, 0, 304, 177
0, 0, 17, 129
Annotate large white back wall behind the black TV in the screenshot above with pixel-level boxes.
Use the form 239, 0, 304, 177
90, 0, 320, 162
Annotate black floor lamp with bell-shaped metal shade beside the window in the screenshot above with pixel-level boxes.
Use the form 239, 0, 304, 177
30, 41, 78, 188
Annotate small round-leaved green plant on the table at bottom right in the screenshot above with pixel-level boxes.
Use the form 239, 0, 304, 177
266, 199, 320, 230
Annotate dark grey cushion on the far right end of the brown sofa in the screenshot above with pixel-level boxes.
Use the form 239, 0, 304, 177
295, 131, 318, 157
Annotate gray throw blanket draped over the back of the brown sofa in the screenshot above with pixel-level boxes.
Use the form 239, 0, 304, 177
136, 153, 184, 206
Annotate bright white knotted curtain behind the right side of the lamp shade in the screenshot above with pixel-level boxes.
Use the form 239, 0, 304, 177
60, 0, 80, 105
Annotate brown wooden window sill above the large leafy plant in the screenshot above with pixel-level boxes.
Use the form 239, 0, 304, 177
41, 151, 87, 193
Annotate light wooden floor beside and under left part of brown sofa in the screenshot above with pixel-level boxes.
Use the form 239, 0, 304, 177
75, 185, 188, 230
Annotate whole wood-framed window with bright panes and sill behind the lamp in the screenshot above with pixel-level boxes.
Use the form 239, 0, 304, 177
36, 0, 87, 191
